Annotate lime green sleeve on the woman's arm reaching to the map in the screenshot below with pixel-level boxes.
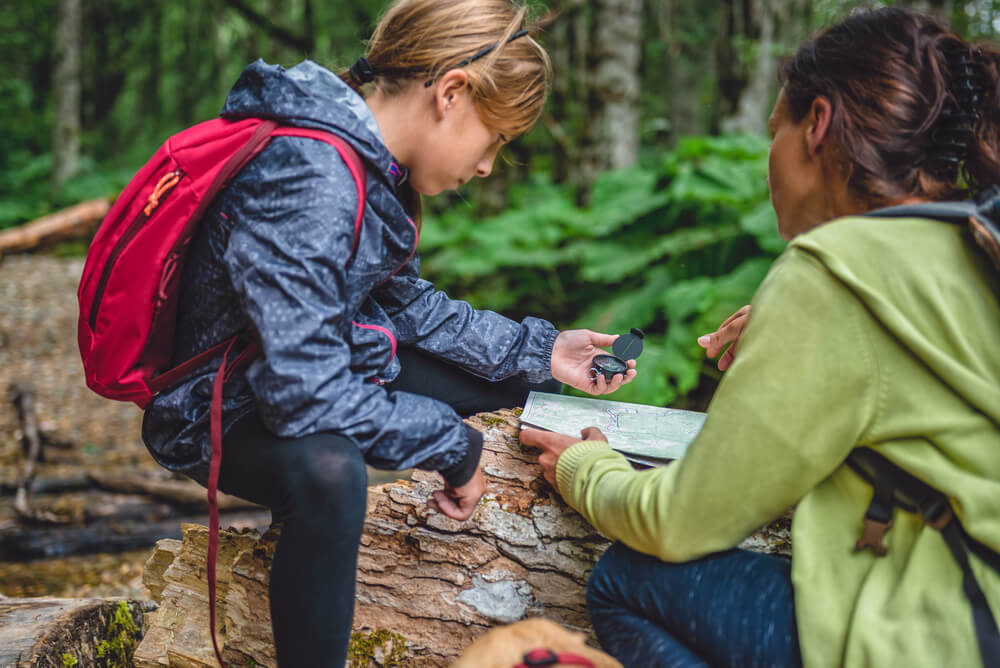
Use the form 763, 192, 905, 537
556, 246, 879, 561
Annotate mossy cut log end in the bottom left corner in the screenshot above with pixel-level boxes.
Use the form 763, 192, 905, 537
0, 597, 143, 668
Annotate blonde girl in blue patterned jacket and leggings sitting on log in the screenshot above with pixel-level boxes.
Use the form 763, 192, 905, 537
143, 0, 635, 666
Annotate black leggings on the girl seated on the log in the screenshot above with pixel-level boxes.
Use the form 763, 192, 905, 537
219, 350, 561, 668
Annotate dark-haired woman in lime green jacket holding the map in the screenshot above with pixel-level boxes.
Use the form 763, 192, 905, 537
522, 9, 1000, 667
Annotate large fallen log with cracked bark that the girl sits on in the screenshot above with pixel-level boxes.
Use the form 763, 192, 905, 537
134, 411, 790, 668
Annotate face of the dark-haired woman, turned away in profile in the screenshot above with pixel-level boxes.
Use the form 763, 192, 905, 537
767, 91, 835, 241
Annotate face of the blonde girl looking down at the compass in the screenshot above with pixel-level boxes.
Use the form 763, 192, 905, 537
408, 81, 506, 195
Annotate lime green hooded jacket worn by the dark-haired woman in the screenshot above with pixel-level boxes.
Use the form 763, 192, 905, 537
556, 218, 1000, 666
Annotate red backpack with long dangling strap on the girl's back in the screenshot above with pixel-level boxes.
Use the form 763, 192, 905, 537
77, 118, 365, 664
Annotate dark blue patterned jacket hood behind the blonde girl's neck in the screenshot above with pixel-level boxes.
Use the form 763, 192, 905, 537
221, 60, 393, 174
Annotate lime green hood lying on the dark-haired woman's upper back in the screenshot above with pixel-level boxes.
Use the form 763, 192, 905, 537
790, 217, 1000, 424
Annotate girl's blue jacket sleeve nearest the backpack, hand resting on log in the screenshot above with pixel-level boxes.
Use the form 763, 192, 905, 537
223, 138, 478, 484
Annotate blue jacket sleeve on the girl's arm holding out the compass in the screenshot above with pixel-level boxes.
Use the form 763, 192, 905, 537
378, 258, 559, 383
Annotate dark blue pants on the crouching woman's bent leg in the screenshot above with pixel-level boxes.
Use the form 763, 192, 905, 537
587, 543, 802, 668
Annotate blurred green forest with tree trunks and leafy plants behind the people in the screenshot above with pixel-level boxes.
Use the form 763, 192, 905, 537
0, 0, 1000, 408
